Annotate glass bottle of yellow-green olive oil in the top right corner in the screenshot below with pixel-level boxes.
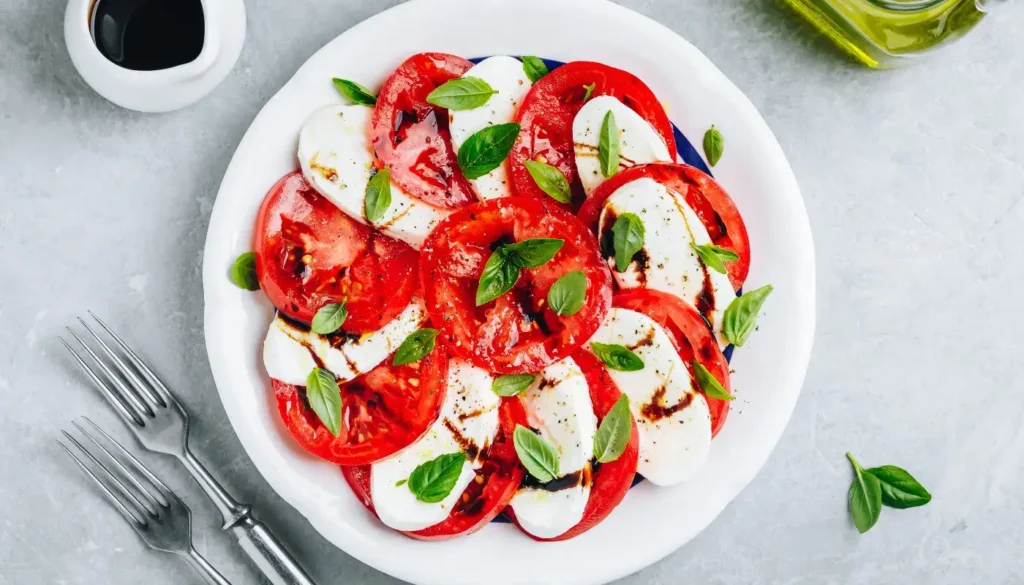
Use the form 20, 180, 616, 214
784, 0, 1006, 69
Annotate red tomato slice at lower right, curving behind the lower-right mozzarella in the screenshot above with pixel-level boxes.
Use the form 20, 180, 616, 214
611, 289, 732, 438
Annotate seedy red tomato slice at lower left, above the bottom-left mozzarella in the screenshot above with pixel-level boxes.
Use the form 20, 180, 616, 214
271, 348, 449, 465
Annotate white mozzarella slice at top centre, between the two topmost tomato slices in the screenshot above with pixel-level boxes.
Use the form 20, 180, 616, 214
449, 55, 532, 201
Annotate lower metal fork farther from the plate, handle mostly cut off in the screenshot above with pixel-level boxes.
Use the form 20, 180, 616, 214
57, 417, 230, 585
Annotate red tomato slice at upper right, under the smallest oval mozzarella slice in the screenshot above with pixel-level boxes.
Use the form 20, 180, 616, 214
511, 61, 676, 209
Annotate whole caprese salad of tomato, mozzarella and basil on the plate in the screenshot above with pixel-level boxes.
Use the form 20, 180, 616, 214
231, 53, 771, 540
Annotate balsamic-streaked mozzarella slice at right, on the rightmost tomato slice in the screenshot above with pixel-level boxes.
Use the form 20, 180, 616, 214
599, 178, 736, 343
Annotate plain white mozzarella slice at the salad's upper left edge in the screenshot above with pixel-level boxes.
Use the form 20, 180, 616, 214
298, 106, 450, 249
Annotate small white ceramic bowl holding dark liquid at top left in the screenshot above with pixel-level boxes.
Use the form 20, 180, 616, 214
65, 0, 246, 112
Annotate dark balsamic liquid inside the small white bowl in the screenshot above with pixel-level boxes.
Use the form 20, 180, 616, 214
92, 0, 206, 71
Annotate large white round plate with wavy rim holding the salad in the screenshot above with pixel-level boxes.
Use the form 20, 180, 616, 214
203, 0, 814, 585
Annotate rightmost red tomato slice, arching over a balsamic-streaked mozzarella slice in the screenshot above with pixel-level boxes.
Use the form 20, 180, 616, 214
580, 163, 751, 291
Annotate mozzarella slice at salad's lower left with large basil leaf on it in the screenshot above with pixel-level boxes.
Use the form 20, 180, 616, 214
370, 360, 501, 531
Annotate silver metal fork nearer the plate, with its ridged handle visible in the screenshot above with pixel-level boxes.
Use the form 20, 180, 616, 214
60, 310, 314, 585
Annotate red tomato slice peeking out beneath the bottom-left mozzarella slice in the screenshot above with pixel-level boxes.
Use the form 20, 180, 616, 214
341, 399, 526, 540
